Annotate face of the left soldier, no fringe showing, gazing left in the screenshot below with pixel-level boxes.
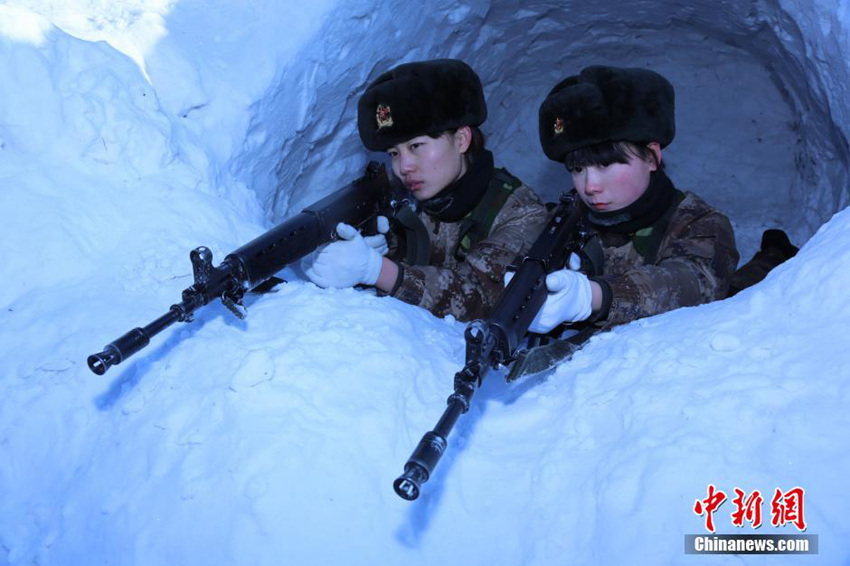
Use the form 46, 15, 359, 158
387, 128, 471, 200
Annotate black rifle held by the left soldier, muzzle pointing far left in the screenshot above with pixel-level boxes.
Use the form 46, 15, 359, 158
87, 161, 391, 375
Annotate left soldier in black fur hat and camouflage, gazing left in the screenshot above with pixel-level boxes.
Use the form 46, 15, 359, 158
305, 59, 547, 320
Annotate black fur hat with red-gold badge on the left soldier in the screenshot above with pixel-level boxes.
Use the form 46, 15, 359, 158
357, 59, 487, 151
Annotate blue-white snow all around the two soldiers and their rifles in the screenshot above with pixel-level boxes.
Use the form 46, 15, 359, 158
0, 0, 850, 566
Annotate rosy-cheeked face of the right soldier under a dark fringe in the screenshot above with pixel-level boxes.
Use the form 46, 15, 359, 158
570, 143, 661, 212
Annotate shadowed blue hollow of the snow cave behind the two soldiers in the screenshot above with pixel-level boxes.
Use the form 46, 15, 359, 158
230, 0, 850, 261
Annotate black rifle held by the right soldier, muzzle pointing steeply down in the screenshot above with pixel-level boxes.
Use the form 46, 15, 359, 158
393, 192, 591, 501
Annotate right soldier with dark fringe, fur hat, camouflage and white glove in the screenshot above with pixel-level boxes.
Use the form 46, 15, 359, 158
531, 66, 738, 333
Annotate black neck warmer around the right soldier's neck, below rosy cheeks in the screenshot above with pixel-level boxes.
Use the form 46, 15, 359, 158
587, 169, 676, 234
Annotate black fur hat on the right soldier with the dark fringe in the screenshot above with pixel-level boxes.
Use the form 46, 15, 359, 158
540, 66, 676, 161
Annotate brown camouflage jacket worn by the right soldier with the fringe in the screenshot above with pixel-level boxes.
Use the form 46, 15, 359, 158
594, 192, 738, 328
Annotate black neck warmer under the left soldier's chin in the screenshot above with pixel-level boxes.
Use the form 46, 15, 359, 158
422, 149, 493, 222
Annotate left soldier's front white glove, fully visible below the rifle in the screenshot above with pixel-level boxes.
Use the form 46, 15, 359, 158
304, 222, 384, 288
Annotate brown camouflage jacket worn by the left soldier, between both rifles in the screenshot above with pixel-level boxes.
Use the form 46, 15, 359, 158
391, 185, 548, 321
